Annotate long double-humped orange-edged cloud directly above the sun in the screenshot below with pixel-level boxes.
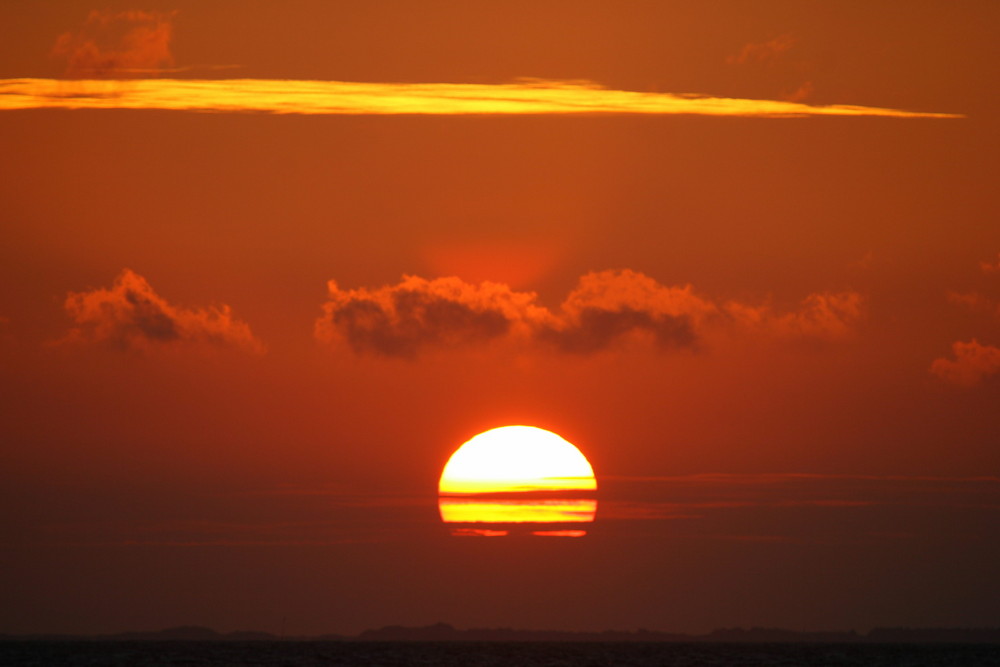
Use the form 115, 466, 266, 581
315, 270, 861, 359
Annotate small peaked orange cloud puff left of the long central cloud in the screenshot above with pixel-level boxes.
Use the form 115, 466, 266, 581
65, 269, 264, 353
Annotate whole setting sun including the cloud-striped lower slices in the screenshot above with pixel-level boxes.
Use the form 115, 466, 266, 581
438, 426, 597, 537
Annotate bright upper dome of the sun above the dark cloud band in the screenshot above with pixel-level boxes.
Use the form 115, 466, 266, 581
438, 426, 597, 494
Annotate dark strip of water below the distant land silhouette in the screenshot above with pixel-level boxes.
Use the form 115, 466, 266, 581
0, 641, 1000, 667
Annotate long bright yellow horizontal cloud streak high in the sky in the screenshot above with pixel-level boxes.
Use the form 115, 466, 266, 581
0, 79, 961, 118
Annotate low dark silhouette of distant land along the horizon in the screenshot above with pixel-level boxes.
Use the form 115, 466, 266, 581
0, 623, 1000, 644
